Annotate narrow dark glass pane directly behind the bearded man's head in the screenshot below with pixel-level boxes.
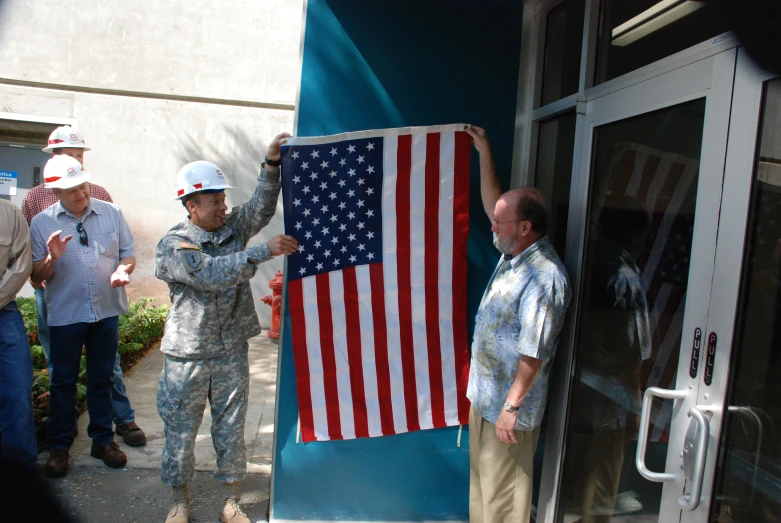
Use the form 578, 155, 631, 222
534, 113, 575, 260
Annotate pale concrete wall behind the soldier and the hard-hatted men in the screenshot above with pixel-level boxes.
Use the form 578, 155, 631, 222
0, 0, 303, 326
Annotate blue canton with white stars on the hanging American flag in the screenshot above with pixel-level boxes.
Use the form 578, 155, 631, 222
282, 138, 382, 280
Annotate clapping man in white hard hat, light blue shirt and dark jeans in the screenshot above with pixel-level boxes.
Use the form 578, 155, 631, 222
30, 155, 136, 477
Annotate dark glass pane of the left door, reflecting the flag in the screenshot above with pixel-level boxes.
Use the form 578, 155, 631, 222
558, 99, 705, 523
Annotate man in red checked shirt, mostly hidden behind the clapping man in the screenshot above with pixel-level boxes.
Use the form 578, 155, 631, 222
22, 125, 146, 447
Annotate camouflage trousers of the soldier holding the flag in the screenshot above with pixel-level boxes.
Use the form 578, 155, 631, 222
157, 343, 249, 487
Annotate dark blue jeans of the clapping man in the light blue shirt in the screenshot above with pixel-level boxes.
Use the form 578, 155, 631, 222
49, 316, 119, 450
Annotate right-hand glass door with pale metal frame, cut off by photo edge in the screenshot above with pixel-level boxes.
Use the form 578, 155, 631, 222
684, 51, 781, 523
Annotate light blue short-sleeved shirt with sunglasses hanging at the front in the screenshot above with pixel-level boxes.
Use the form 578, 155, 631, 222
30, 199, 134, 327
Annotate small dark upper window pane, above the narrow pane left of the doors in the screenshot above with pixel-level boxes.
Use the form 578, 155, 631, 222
542, 0, 586, 105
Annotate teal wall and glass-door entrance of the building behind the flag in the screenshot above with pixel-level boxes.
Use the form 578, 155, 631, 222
271, 0, 781, 523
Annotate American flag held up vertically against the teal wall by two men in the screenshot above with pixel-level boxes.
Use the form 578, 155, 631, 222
282, 125, 471, 442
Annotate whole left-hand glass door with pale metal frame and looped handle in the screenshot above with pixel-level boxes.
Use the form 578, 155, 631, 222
540, 50, 737, 523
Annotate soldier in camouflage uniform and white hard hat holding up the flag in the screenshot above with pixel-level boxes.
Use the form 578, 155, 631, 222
155, 133, 298, 523
